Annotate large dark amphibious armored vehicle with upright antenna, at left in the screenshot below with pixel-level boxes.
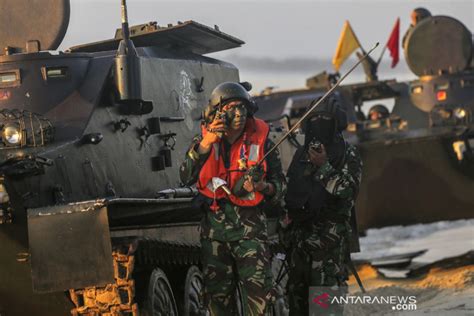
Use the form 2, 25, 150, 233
0, 0, 270, 316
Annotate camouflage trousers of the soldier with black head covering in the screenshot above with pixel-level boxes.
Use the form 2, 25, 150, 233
287, 227, 347, 316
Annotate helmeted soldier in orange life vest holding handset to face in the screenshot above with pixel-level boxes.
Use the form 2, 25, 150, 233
180, 82, 285, 315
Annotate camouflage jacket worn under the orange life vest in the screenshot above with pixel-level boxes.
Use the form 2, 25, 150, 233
180, 135, 285, 241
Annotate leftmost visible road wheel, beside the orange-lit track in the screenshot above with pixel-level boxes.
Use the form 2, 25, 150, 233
146, 268, 178, 316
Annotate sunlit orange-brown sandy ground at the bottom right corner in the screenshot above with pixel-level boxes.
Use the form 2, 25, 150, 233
345, 265, 474, 316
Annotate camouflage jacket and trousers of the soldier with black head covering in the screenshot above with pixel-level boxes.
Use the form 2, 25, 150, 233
286, 145, 362, 315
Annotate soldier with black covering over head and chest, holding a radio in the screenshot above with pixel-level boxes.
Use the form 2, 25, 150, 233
282, 98, 362, 315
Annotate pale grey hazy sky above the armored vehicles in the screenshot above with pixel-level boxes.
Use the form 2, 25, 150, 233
60, 0, 474, 89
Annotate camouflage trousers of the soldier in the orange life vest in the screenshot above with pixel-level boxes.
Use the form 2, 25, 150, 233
201, 238, 272, 316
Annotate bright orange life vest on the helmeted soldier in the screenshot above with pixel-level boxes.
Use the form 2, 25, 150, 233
197, 118, 269, 207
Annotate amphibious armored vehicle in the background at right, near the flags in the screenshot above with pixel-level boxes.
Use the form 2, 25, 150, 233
256, 12, 474, 229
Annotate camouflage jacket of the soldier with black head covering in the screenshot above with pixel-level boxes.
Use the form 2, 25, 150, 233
291, 144, 362, 251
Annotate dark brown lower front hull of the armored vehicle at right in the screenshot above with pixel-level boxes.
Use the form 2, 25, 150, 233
356, 128, 474, 229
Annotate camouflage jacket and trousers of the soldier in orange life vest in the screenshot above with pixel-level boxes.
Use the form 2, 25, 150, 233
180, 136, 285, 315
